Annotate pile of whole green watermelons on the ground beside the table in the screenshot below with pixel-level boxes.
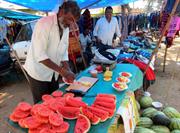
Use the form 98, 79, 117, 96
134, 96, 180, 133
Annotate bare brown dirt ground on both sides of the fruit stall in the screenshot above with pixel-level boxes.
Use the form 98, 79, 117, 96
0, 38, 180, 133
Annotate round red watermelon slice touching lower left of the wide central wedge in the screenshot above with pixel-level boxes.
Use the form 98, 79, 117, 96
49, 113, 63, 126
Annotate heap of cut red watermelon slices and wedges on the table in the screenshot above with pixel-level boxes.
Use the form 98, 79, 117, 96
9, 91, 116, 133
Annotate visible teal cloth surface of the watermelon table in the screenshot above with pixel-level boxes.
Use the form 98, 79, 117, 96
9, 64, 143, 133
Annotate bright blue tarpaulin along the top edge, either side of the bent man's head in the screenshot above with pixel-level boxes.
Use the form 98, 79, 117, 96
5, 0, 137, 12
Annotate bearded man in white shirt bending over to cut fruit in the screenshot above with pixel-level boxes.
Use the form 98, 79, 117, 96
24, 1, 80, 103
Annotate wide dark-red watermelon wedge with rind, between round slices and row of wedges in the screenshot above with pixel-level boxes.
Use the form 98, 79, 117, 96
58, 106, 80, 120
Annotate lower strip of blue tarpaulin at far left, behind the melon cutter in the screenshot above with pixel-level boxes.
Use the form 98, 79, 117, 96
0, 8, 40, 20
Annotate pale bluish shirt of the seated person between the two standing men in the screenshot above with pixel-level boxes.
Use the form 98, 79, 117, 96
79, 33, 91, 51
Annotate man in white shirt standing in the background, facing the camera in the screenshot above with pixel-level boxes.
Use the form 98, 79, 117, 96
93, 6, 121, 47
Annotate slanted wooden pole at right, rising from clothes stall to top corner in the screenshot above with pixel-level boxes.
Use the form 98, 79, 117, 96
144, 0, 179, 75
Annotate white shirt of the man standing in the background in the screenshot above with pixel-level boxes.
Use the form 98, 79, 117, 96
93, 17, 121, 45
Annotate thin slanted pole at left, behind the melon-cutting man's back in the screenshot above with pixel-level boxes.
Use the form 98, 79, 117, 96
5, 37, 30, 84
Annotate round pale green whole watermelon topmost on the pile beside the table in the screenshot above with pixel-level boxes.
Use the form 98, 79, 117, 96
139, 96, 153, 108
